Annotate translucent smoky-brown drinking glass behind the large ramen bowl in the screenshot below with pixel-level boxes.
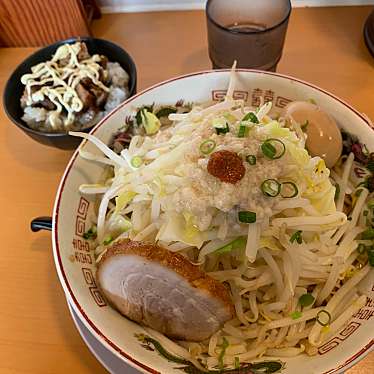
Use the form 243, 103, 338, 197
206, 0, 291, 71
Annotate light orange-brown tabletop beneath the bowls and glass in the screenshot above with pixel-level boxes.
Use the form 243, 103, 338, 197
0, 7, 374, 374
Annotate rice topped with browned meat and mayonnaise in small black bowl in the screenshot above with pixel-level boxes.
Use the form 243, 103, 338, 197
20, 41, 129, 132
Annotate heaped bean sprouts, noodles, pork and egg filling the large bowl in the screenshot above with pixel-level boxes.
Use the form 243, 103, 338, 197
71, 71, 374, 371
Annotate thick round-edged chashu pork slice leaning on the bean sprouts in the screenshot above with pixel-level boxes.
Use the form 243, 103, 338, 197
96, 240, 234, 341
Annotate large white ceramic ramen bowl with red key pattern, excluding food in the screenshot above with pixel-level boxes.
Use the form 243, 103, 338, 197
53, 70, 374, 374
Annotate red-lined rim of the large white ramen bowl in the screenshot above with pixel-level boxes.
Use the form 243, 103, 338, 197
52, 68, 374, 374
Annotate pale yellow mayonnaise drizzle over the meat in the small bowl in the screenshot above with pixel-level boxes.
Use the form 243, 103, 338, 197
21, 42, 109, 129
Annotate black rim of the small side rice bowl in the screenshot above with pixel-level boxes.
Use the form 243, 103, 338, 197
2, 36, 137, 138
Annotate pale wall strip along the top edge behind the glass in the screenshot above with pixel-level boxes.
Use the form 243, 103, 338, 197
98, 0, 374, 13
